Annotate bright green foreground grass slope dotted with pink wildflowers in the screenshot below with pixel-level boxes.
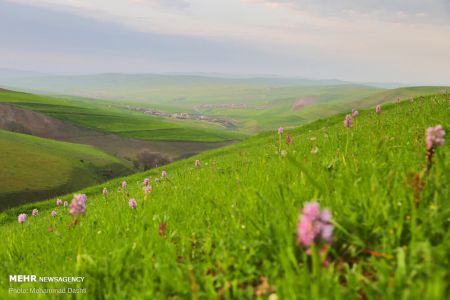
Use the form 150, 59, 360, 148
0, 95, 450, 299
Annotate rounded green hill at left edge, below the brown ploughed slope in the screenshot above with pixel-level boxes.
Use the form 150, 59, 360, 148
0, 130, 131, 209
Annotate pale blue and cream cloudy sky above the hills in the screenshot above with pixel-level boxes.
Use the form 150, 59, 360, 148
0, 0, 450, 84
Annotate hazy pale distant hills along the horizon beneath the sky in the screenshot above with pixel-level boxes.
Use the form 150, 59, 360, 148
0, 68, 407, 95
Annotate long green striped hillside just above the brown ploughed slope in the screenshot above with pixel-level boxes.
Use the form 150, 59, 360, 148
0, 91, 245, 142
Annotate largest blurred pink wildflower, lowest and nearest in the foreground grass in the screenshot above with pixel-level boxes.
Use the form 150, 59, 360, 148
297, 202, 333, 248
